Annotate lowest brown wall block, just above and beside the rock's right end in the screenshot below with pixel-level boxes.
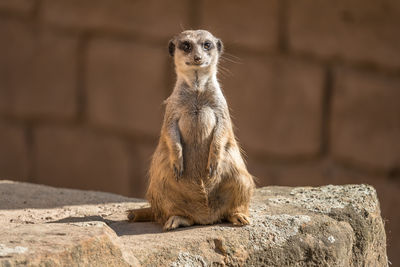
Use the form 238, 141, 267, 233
248, 156, 400, 263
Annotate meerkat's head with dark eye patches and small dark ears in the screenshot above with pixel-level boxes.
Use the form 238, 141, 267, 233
169, 30, 223, 75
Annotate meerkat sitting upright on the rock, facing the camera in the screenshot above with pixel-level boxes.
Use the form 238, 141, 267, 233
128, 30, 254, 231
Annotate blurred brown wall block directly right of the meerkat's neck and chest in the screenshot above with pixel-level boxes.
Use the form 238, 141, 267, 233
221, 56, 324, 157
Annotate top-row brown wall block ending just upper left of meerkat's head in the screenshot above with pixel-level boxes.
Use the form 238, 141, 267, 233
43, 0, 190, 39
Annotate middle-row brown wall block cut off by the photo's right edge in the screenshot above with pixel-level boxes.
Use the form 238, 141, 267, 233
330, 68, 400, 169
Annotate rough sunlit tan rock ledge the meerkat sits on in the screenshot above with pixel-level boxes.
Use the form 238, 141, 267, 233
0, 181, 388, 266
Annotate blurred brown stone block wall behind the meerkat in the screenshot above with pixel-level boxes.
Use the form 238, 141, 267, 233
0, 0, 400, 262
